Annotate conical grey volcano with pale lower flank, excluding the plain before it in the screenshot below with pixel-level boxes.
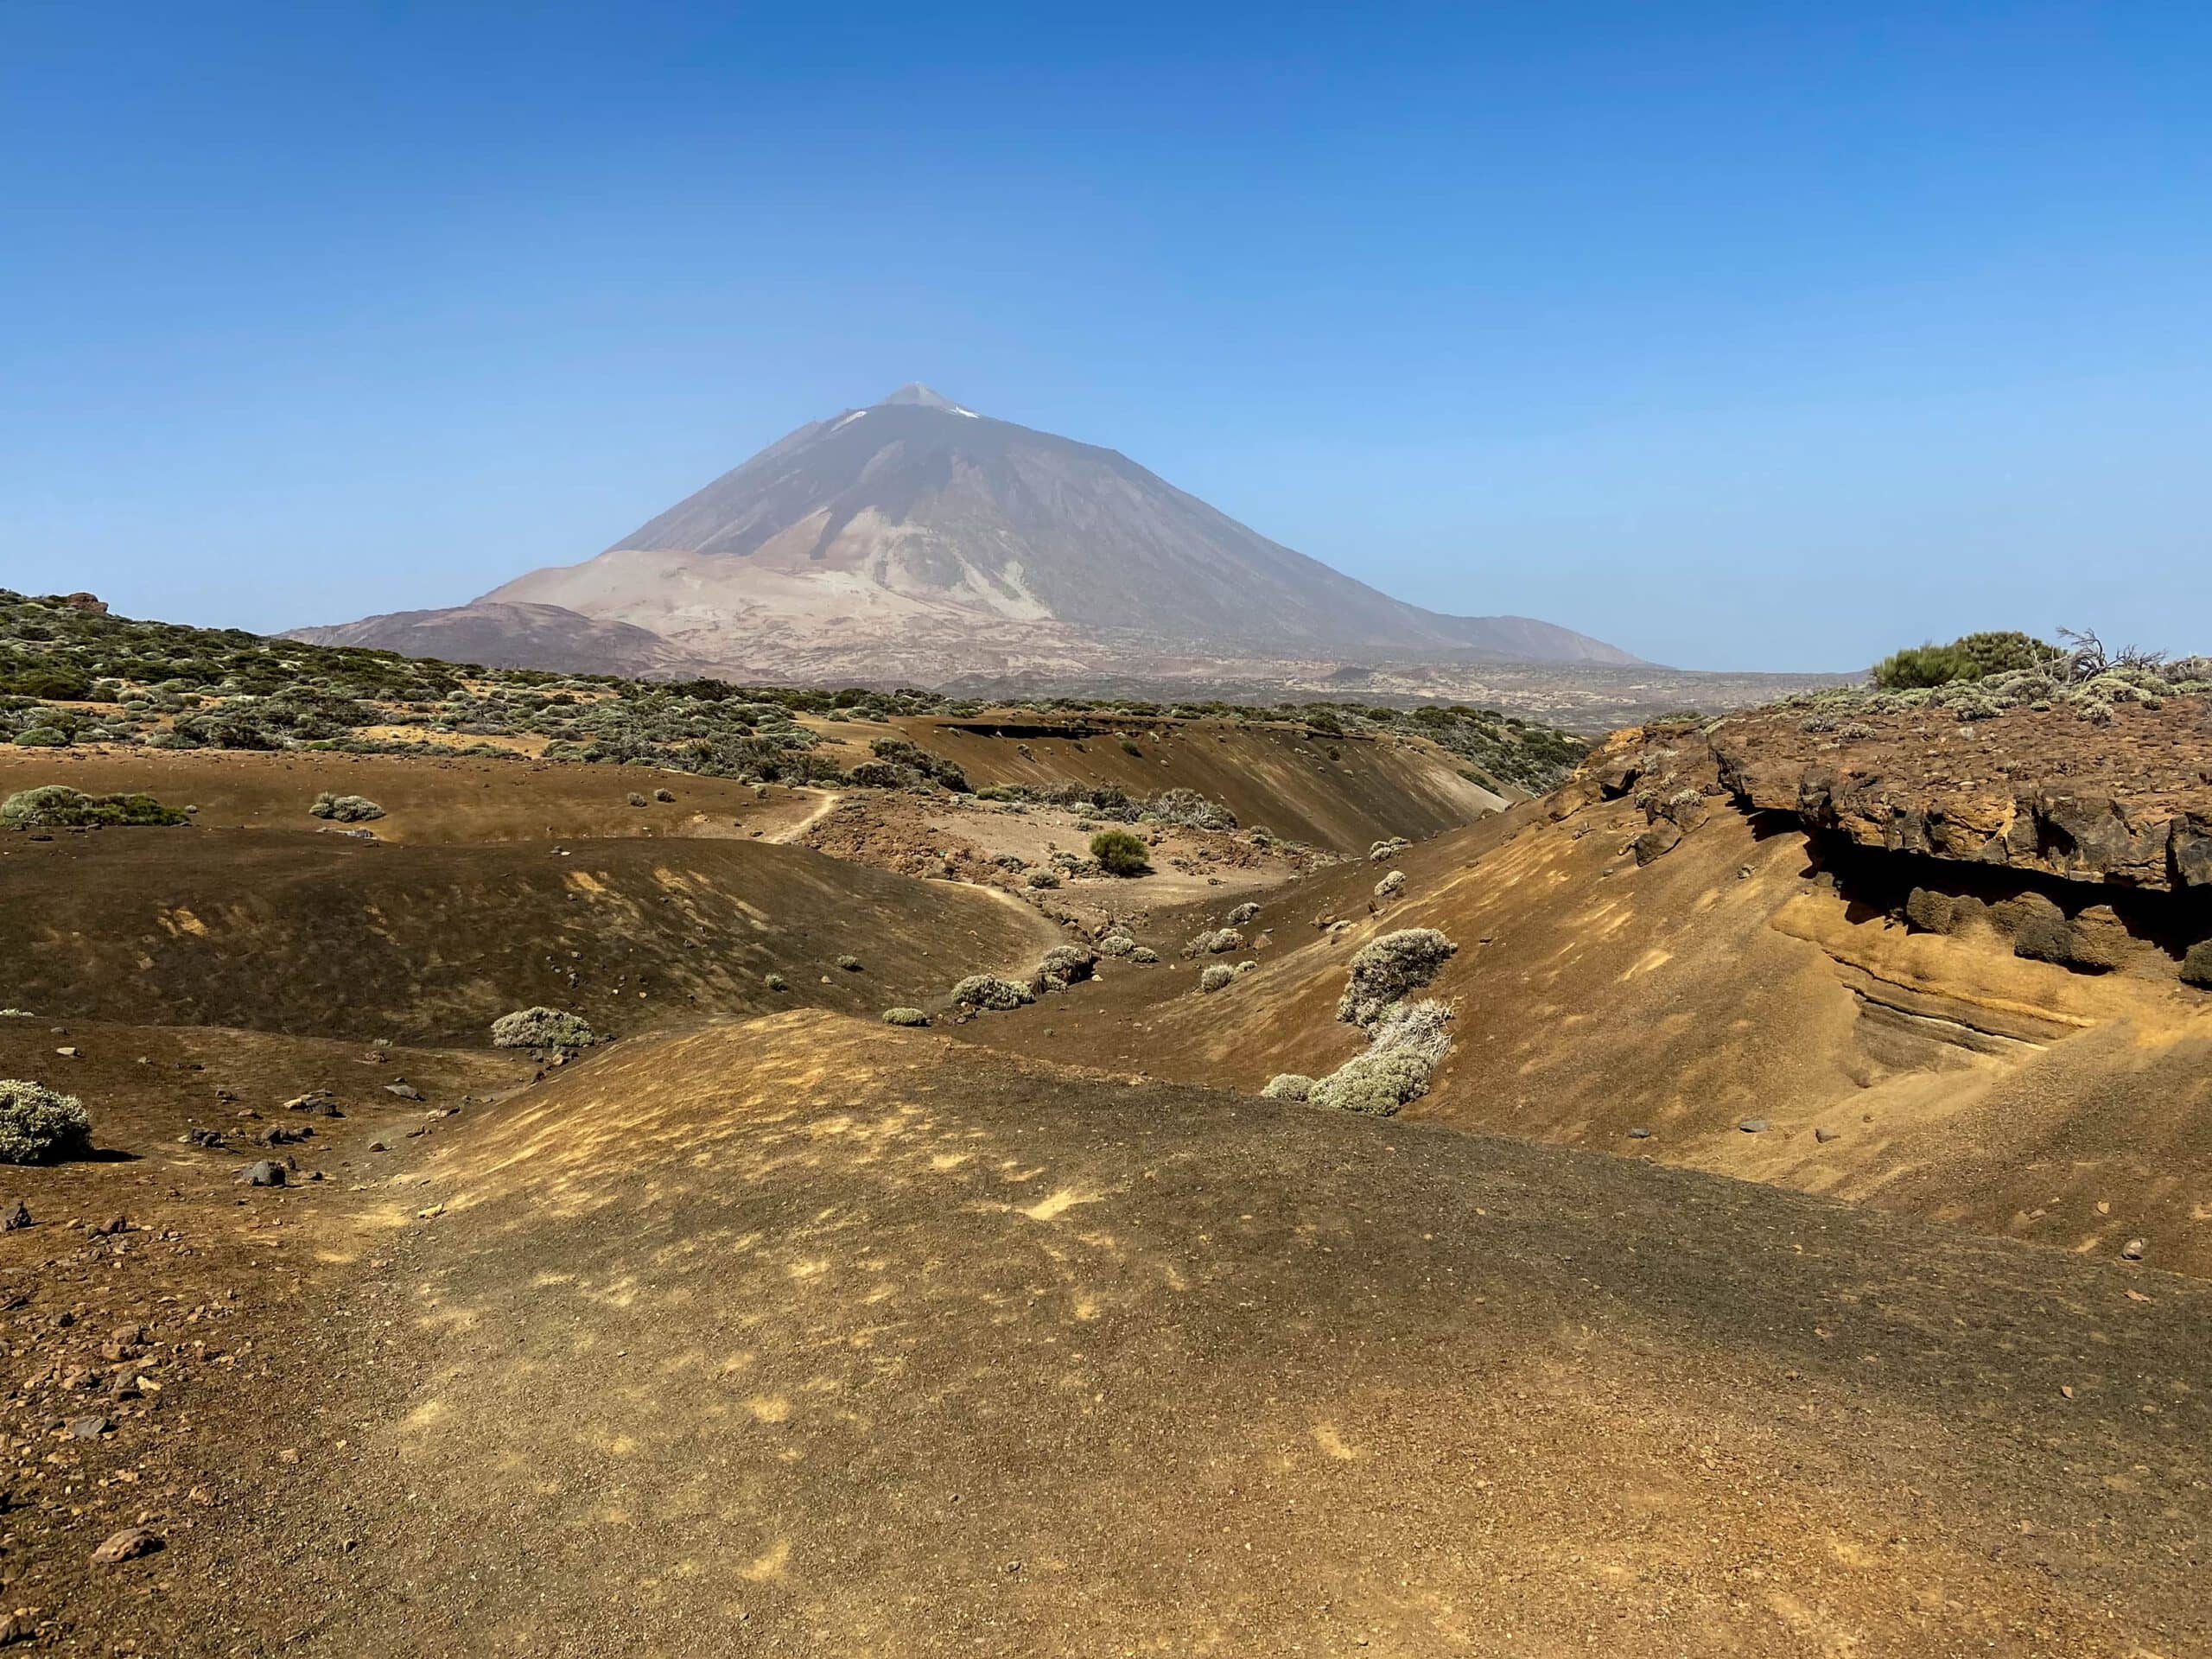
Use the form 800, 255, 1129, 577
302, 385, 1635, 683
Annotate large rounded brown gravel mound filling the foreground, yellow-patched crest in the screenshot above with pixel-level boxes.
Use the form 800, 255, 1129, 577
270, 1015, 2212, 1656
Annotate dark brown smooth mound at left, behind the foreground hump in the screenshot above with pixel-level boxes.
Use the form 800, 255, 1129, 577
0, 830, 1059, 1044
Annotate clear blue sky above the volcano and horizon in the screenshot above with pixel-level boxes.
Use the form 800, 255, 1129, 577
0, 0, 2212, 668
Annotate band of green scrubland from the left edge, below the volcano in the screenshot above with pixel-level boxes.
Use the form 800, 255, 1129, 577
0, 588, 1588, 796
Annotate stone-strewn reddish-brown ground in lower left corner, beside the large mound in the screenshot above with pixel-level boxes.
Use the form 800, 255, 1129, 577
0, 1020, 533, 1655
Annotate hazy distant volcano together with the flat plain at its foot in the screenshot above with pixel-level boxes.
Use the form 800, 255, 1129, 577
294, 385, 1834, 730
